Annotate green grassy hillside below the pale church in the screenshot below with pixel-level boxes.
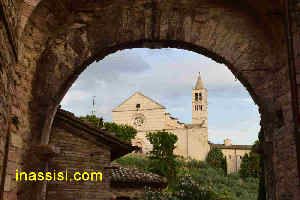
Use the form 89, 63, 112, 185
115, 155, 259, 200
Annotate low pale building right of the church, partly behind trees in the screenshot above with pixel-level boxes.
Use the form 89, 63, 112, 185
209, 139, 252, 173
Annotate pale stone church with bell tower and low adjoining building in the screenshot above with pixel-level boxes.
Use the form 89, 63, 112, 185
112, 73, 251, 173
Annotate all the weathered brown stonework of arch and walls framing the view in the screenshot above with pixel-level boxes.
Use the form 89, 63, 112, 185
0, 0, 300, 200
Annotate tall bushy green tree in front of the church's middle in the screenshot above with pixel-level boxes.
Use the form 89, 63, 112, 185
146, 131, 178, 182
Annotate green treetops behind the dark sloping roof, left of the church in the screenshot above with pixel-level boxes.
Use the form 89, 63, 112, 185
79, 115, 137, 142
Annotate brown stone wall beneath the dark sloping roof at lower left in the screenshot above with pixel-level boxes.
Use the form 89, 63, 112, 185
47, 123, 112, 200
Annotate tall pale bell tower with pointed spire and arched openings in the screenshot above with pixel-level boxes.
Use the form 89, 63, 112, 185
192, 72, 207, 127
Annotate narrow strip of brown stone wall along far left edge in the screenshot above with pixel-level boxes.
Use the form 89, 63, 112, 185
0, 1, 25, 199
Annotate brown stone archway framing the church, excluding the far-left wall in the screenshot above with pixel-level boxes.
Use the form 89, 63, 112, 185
1, 0, 299, 199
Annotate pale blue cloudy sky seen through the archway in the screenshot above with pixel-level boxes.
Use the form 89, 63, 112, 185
61, 48, 260, 144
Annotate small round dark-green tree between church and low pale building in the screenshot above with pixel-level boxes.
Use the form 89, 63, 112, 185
206, 148, 227, 173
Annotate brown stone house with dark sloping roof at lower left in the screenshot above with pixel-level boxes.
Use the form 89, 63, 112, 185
48, 109, 136, 200
